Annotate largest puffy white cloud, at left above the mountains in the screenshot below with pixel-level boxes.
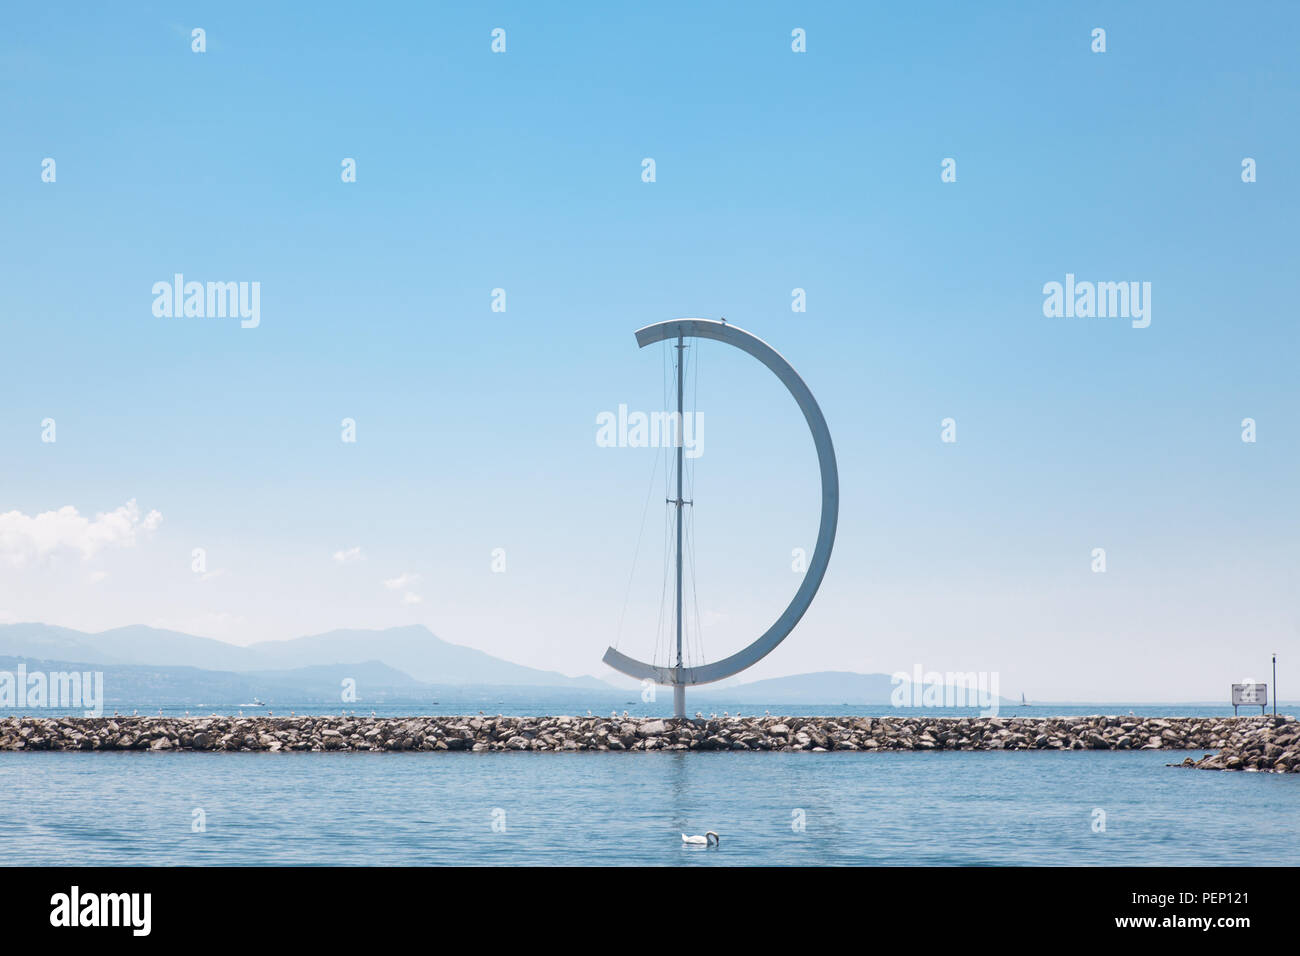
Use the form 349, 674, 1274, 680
0, 498, 163, 567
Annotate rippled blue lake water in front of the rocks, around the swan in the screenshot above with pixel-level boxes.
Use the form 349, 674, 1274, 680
0, 750, 1300, 866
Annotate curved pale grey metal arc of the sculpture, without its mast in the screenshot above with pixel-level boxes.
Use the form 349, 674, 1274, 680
603, 319, 840, 684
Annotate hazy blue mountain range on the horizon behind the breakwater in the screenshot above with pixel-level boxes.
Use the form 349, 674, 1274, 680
0, 623, 1019, 708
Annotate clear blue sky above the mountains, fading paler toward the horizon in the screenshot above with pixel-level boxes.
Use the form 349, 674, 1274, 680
0, 4, 1300, 700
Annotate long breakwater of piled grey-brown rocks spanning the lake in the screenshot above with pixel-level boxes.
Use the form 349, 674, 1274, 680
0, 715, 1300, 771
